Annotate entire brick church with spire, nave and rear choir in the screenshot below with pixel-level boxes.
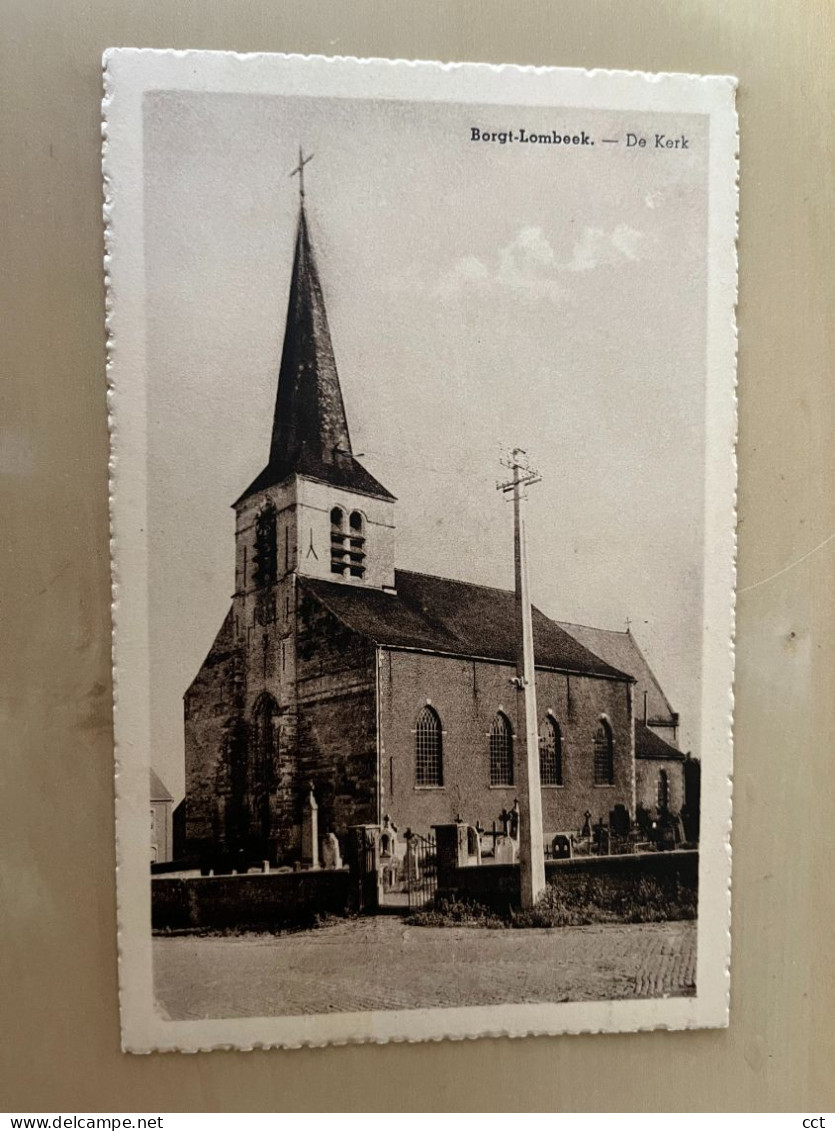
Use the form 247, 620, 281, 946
184, 193, 682, 864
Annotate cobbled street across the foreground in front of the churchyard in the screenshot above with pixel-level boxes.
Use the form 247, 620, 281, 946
154, 916, 696, 1020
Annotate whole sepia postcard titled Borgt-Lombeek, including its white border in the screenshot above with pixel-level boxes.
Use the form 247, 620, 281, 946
103, 50, 737, 1052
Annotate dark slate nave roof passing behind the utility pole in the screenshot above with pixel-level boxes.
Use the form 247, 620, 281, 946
300, 570, 631, 680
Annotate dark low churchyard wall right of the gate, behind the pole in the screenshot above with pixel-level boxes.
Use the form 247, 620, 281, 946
438, 849, 699, 915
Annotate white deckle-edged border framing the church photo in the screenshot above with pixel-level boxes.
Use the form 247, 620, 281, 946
103, 49, 738, 1052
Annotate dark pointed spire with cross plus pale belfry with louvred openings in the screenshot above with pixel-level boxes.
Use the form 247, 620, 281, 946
229, 152, 395, 592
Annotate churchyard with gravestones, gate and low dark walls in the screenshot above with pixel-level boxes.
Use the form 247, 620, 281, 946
152, 789, 698, 931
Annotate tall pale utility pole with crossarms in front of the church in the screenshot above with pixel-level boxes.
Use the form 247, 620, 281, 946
496, 448, 545, 910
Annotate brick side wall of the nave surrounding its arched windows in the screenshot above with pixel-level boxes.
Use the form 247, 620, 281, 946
380, 649, 635, 834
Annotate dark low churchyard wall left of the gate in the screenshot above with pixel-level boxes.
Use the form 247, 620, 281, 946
150, 869, 350, 931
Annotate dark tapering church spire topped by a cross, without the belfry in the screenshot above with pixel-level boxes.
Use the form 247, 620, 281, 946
239, 163, 393, 501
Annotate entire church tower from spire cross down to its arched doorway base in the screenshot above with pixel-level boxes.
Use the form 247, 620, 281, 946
226, 153, 395, 857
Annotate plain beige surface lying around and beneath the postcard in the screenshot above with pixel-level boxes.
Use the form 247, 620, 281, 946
0, 0, 835, 1112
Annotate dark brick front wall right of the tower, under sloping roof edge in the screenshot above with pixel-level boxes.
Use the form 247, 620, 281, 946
296, 595, 378, 837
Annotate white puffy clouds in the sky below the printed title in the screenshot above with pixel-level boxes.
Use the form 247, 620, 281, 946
436, 224, 646, 303
